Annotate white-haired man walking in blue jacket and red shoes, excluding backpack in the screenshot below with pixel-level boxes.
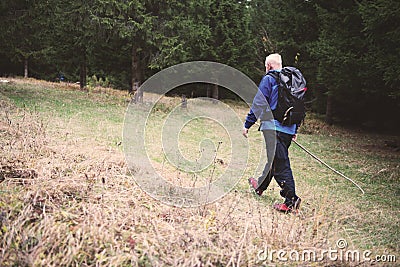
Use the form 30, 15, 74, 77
243, 54, 301, 213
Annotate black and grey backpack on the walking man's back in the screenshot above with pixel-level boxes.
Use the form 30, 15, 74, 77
268, 67, 307, 126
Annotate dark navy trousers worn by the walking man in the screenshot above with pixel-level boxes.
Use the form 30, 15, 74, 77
257, 130, 298, 206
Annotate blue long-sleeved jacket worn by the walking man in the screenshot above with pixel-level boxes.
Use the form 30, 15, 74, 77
244, 70, 297, 135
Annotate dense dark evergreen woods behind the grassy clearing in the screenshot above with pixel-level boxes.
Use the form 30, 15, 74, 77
0, 0, 400, 129
